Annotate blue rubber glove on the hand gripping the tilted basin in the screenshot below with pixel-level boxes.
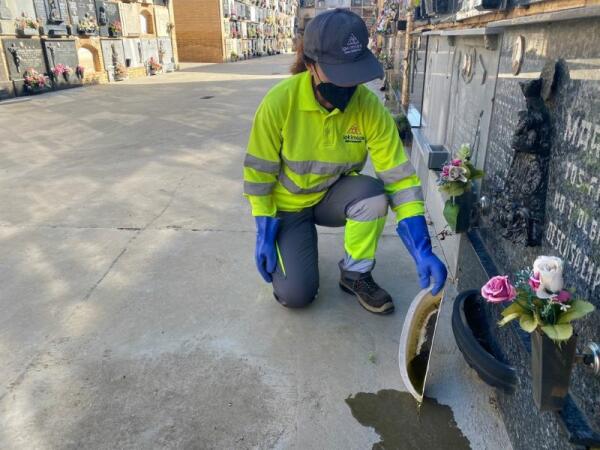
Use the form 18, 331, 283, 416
396, 216, 448, 295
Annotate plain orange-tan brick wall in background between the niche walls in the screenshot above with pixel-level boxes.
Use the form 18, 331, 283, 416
173, 0, 223, 62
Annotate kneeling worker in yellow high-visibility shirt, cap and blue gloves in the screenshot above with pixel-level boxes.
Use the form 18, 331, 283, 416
244, 9, 446, 314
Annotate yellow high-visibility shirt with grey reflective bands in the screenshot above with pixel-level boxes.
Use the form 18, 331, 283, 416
244, 72, 424, 221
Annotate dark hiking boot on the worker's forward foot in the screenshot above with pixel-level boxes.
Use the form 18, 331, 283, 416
340, 270, 394, 314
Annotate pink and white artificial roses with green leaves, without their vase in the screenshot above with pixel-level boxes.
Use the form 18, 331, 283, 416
481, 256, 594, 343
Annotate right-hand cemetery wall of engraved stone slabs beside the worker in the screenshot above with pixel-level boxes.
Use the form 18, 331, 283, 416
388, 6, 600, 450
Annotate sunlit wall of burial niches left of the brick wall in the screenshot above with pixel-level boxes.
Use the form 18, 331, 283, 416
0, 0, 176, 100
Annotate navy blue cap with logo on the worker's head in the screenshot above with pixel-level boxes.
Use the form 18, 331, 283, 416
304, 8, 383, 86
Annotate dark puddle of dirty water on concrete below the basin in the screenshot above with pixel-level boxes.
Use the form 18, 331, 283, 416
346, 389, 471, 450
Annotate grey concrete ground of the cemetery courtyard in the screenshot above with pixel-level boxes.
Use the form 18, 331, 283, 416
0, 56, 510, 449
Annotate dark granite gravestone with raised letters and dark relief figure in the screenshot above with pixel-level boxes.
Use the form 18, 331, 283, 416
481, 19, 600, 449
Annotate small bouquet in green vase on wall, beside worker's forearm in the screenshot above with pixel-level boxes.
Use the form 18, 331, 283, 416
438, 144, 483, 233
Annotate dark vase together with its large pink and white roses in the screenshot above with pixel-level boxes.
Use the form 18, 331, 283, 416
481, 256, 600, 411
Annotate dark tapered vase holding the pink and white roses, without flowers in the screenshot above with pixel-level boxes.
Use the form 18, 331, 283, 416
531, 330, 577, 411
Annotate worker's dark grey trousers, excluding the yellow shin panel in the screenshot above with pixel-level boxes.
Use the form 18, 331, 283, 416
273, 175, 388, 308
